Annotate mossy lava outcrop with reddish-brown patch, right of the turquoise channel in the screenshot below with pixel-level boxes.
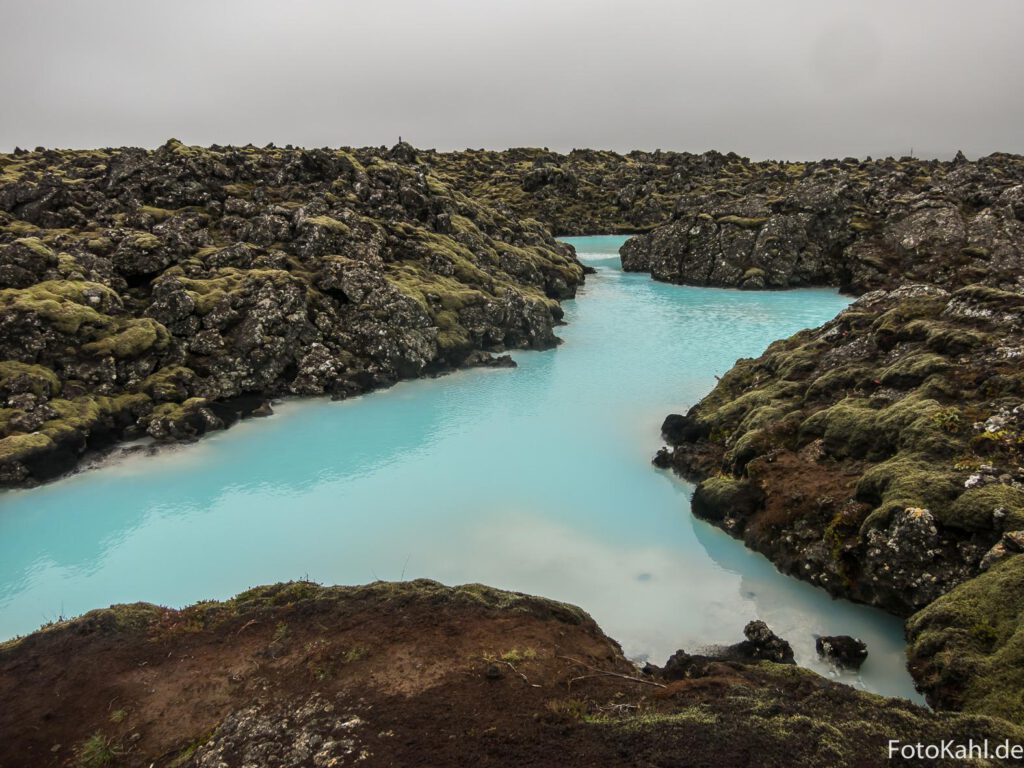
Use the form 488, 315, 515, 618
656, 285, 1024, 615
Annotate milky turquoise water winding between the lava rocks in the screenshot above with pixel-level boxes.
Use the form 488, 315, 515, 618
0, 238, 913, 695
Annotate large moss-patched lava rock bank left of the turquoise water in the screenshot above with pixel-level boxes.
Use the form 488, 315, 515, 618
0, 141, 584, 485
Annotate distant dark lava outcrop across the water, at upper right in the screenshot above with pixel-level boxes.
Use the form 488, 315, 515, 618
622, 155, 1024, 294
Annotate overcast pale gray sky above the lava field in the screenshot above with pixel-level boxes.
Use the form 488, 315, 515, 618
0, 0, 1024, 159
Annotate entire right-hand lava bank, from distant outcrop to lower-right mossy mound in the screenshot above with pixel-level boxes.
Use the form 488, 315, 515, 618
623, 155, 1024, 722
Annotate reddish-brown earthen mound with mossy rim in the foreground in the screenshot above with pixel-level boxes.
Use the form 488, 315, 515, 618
0, 581, 1024, 768
